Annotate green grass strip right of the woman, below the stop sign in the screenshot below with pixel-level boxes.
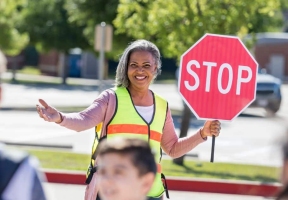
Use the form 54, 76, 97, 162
162, 159, 280, 182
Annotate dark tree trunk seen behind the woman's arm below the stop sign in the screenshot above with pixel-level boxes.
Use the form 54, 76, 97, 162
173, 102, 192, 165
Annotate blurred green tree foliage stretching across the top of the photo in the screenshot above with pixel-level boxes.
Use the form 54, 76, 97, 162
0, 0, 288, 59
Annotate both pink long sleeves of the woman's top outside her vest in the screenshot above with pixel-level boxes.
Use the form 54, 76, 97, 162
60, 89, 205, 158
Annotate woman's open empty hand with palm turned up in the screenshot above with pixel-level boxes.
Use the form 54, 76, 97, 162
36, 99, 63, 123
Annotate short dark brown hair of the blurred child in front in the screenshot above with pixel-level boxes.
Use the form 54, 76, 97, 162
97, 137, 157, 176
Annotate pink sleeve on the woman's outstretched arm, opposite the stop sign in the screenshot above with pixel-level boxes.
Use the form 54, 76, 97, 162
60, 90, 109, 132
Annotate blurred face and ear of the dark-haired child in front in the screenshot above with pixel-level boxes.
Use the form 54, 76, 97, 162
97, 153, 154, 200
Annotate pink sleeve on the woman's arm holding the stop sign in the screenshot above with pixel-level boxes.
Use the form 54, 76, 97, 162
161, 108, 206, 158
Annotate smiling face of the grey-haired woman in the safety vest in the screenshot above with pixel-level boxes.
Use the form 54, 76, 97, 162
128, 51, 157, 89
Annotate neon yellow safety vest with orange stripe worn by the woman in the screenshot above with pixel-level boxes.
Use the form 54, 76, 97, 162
107, 87, 167, 197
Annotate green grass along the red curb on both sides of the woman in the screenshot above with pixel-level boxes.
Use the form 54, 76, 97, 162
23, 149, 280, 182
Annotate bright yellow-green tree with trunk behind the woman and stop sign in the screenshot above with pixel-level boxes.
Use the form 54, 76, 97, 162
114, 0, 285, 164
